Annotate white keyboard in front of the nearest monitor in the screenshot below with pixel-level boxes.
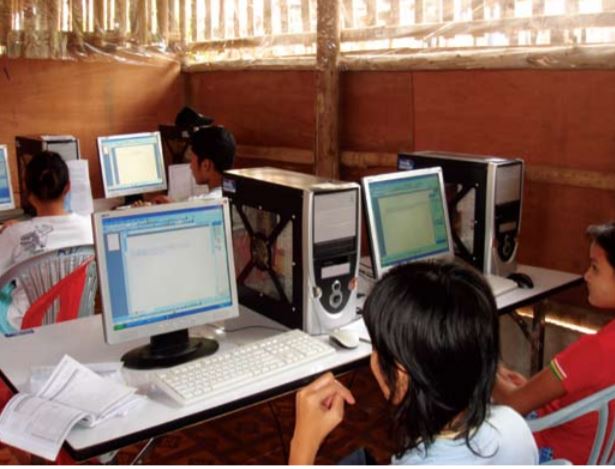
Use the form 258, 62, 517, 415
154, 330, 335, 405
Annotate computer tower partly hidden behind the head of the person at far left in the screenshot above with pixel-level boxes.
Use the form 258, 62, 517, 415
15, 135, 80, 215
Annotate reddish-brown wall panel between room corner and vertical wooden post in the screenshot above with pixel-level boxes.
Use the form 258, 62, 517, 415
188, 70, 315, 150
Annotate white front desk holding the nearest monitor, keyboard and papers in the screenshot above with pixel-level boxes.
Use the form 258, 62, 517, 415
0, 308, 371, 460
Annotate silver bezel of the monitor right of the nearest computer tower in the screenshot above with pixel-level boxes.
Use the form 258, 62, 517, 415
361, 166, 455, 279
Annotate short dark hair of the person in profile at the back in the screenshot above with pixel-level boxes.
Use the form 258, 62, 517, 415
190, 125, 235, 173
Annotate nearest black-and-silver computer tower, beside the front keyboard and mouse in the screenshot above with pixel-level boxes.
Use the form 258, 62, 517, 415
222, 168, 360, 334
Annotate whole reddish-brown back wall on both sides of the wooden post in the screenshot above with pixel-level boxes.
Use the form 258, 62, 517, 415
187, 70, 615, 273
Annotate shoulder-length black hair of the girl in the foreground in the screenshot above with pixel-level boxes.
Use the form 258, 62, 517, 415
363, 262, 499, 457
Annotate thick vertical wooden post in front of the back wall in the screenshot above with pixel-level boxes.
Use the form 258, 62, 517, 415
314, 0, 340, 178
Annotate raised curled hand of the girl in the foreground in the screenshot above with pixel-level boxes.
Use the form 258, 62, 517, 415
289, 373, 355, 464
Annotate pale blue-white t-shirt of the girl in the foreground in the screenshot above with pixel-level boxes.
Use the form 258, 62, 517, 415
391, 406, 538, 466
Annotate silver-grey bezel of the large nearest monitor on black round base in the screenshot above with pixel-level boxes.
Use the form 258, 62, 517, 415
93, 198, 239, 344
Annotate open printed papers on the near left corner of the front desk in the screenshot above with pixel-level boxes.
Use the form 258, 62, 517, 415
0, 355, 144, 461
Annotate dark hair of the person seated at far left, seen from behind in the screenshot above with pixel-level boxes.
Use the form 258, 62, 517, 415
26, 151, 68, 201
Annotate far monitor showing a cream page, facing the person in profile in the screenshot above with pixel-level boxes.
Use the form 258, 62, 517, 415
97, 132, 167, 197
